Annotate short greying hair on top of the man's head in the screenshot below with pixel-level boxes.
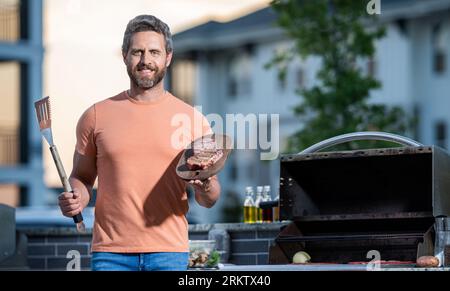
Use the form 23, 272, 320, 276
122, 15, 173, 54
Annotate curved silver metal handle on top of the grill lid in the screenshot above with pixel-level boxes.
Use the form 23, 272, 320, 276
300, 131, 423, 154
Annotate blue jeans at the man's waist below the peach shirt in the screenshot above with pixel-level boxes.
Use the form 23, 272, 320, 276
91, 252, 189, 271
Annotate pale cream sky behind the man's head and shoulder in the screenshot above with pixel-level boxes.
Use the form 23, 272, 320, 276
43, 0, 270, 186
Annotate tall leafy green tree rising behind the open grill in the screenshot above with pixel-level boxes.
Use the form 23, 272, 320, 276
267, 0, 412, 152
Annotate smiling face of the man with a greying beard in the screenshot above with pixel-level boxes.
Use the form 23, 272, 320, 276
123, 31, 172, 90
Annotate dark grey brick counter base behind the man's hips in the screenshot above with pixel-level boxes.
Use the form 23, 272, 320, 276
21, 223, 282, 270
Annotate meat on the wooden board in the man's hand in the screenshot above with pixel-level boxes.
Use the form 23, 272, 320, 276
186, 137, 223, 171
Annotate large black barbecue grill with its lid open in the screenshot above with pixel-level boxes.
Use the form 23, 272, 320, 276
269, 132, 450, 266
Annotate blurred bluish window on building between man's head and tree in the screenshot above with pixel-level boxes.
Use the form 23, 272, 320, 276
227, 51, 252, 99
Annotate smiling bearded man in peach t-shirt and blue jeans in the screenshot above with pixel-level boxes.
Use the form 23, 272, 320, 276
59, 15, 220, 270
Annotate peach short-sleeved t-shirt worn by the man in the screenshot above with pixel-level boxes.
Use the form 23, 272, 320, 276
76, 92, 211, 253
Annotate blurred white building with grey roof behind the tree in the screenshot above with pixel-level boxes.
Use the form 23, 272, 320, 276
170, 0, 450, 221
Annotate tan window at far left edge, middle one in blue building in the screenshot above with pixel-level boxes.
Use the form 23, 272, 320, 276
0, 62, 20, 166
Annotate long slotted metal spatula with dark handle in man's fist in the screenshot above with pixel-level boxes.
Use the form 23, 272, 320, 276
34, 97, 86, 232
